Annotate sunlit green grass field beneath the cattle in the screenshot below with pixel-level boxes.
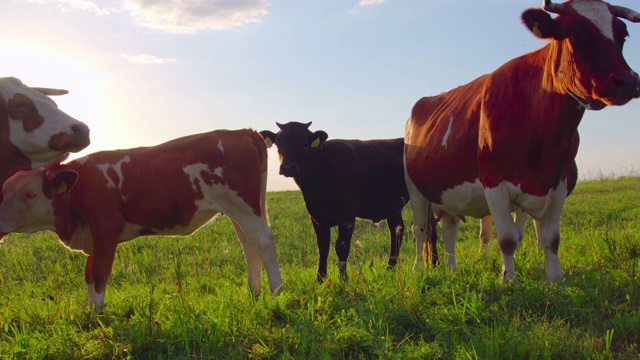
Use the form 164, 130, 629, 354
0, 177, 640, 359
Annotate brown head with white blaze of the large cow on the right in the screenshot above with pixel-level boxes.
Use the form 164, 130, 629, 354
522, 0, 640, 110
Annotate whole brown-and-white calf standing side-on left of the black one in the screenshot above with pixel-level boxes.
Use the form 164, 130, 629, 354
0, 129, 282, 313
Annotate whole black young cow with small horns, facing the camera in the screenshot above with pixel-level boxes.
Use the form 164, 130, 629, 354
260, 122, 438, 283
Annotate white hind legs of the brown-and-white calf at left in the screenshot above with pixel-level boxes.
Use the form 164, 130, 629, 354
231, 215, 282, 296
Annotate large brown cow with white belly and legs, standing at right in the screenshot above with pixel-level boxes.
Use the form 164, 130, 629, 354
405, 0, 640, 282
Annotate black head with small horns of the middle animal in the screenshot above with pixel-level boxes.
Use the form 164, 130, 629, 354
260, 122, 329, 178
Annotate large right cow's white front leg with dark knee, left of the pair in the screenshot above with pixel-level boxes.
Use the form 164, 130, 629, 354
484, 185, 519, 283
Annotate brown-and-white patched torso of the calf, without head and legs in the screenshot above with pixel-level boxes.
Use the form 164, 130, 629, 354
58, 130, 267, 240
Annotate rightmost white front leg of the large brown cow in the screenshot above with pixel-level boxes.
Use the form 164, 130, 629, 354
538, 180, 567, 282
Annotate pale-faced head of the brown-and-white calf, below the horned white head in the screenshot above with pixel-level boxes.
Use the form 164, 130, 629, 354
0, 168, 78, 236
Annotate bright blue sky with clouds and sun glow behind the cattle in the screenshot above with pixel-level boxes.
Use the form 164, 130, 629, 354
0, 0, 640, 191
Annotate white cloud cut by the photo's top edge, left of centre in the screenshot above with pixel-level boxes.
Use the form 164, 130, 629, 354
124, 0, 270, 33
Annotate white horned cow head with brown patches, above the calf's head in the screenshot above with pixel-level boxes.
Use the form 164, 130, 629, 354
0, 77, 89, 169
